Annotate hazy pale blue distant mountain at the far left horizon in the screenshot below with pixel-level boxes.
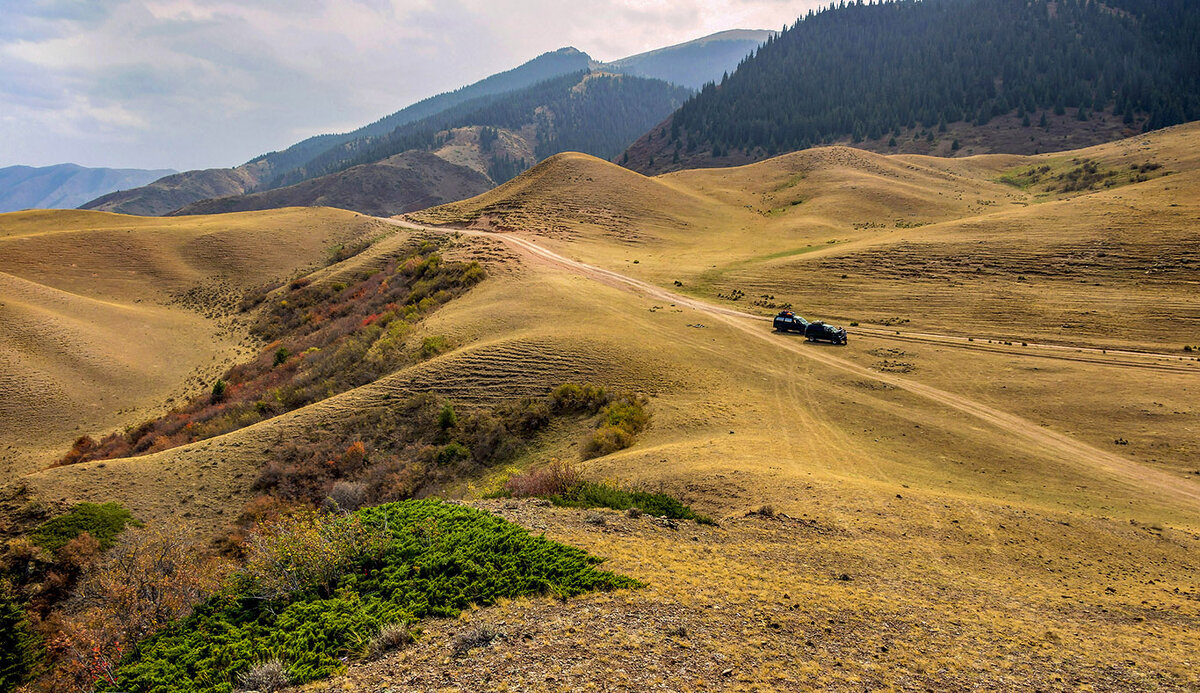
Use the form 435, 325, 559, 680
0, 163, 175, 212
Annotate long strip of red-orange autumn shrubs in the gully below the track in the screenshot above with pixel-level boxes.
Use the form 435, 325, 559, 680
56, 243, 484, 464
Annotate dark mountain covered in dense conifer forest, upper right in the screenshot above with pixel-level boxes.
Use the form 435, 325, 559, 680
620, 0, 1200, 173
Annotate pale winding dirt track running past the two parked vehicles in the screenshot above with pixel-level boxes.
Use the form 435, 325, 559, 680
383, 219, 1200, 504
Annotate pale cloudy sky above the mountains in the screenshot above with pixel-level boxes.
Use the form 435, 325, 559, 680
0, 0, 818, 170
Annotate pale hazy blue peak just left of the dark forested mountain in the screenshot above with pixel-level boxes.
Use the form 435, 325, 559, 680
598, 29, 775, 90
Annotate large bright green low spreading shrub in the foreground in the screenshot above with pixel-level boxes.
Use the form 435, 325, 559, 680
106, 500, 640, 693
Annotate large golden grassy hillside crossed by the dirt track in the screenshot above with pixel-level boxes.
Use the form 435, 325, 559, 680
0, 123, 1200, 691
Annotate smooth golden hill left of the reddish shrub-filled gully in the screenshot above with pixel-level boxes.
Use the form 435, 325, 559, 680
0, 210, 379, 480
